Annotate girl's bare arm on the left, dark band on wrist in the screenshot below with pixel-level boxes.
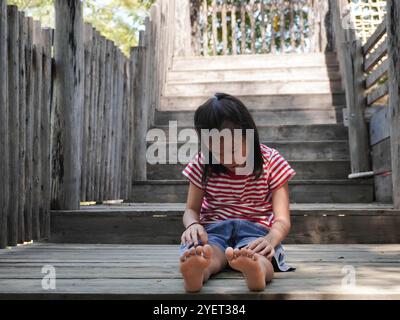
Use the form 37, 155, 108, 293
181, 182, 208, 246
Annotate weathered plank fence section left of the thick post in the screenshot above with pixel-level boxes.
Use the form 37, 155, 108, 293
0, 2, 52, 248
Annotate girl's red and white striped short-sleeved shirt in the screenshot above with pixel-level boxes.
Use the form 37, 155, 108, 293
182, 144, 296, 228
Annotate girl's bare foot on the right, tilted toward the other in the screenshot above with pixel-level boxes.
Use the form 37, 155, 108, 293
225, 247, 267, 291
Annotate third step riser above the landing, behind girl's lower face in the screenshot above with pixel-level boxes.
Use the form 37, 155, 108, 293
148, 140, 350, 161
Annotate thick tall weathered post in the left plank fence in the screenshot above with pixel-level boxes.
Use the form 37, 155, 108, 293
52, 0, 84, 210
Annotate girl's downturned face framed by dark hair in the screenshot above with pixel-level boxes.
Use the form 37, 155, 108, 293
209, 135, 248, 172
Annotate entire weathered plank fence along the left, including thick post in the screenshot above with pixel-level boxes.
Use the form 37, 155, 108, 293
0, 0, 159, 248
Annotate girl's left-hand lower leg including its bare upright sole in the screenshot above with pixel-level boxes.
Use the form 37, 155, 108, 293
180, 244, 227, 292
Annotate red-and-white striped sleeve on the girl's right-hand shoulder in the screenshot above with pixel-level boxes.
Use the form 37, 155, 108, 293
268, 150, 296, 191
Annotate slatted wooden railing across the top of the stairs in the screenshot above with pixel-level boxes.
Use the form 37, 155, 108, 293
192, 0, 329, 56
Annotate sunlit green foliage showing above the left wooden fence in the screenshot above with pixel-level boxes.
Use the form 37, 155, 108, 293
8, 0, 155, 54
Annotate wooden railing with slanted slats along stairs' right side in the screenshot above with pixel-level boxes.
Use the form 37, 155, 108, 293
331, 0, 400, 209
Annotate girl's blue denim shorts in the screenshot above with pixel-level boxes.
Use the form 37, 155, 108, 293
179, 219, 295, 272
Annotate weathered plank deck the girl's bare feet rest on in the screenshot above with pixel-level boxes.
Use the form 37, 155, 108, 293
0, 243, 400, 299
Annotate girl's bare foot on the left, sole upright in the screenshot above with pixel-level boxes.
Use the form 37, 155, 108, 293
180, 244, 212, 292
